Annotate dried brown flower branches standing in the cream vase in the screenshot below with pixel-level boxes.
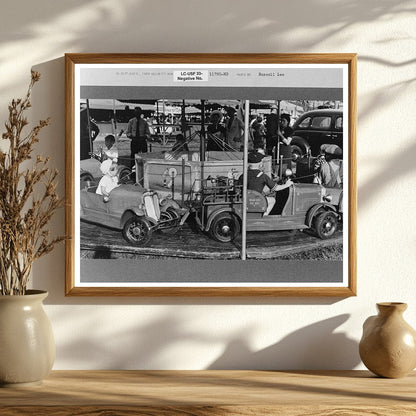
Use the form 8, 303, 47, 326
0, 71, 65, 295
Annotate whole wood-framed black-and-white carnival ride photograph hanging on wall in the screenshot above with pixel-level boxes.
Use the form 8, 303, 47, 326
65, 54, 356, 297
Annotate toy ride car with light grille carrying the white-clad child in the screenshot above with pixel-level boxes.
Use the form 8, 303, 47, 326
80, 184, 188, 246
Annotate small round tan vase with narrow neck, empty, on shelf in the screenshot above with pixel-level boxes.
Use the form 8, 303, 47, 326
359, 302, 416, 378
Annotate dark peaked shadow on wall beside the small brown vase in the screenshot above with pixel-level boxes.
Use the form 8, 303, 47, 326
207, 314, 360, 370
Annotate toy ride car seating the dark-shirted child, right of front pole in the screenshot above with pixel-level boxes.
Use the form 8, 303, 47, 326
189, 173, 342, 242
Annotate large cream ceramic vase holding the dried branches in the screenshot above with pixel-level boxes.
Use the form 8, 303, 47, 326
0, 290, 55, 387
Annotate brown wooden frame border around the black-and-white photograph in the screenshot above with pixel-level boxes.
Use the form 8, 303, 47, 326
65, 53, 357, 297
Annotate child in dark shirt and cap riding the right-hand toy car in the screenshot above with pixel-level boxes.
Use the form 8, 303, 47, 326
239, 152, 293, 215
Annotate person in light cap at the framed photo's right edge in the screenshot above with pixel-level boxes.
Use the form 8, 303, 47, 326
314, 144, 343, 188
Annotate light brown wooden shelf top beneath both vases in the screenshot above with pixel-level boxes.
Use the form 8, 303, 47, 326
0, 371, 416, 416
